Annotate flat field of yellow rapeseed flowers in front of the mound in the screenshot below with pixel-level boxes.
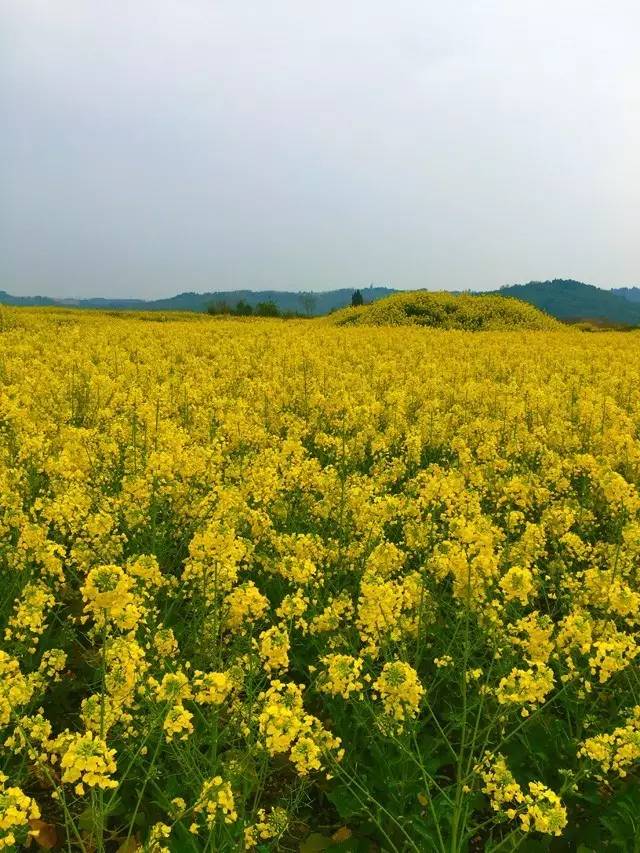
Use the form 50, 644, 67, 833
0, 309, 640, 853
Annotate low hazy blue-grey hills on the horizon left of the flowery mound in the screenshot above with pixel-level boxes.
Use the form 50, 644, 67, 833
0, 285, 398, 315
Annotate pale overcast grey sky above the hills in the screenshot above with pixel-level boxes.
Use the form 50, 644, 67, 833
0, 0, 640, 298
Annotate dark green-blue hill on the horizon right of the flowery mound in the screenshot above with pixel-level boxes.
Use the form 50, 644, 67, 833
494, 278, 640, 326
